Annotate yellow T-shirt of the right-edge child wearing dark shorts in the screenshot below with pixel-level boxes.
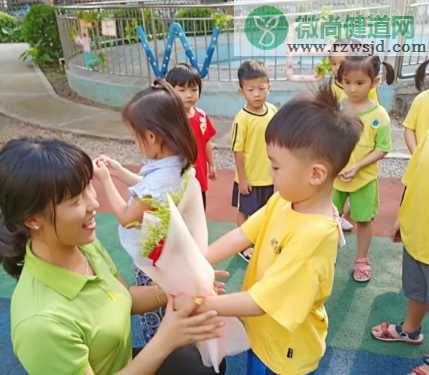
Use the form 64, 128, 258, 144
399, 131, 429, 265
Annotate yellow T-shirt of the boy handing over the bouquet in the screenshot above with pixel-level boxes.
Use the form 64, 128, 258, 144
241, 193, 339, 375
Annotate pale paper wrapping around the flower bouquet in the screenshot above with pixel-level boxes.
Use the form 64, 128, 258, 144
119, 176, 249, 372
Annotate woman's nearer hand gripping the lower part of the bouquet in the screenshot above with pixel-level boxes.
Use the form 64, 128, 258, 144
156, 296, 224, 351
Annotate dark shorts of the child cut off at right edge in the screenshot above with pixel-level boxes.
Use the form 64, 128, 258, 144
402, 247, 429, 307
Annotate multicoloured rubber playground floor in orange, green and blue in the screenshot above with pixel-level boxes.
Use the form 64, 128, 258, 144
0, 171, 422, 375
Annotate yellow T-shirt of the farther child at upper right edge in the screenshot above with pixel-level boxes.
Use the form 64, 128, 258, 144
404, 90, 429, 145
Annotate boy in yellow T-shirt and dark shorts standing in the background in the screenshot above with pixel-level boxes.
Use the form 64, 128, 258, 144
232, 60, 277, 262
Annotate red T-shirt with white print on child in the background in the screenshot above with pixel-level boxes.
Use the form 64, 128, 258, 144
188, 107, 216, 191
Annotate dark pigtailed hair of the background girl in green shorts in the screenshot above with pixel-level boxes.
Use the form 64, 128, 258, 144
337, 55, 395, 85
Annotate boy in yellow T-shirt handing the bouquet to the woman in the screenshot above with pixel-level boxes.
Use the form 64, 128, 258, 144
176, 83, 361, 375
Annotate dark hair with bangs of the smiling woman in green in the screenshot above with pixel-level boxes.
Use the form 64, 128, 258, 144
0, 138, 93, 278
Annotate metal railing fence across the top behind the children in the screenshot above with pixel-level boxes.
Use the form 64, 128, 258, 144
56, 0, 429, 82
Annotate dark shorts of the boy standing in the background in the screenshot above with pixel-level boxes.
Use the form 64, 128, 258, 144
232, 182, 274, 216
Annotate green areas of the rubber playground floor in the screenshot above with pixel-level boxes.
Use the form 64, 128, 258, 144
0, 214, 429, 358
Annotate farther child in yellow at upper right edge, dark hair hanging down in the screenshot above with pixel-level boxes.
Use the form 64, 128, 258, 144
403, 60, 429, 154
